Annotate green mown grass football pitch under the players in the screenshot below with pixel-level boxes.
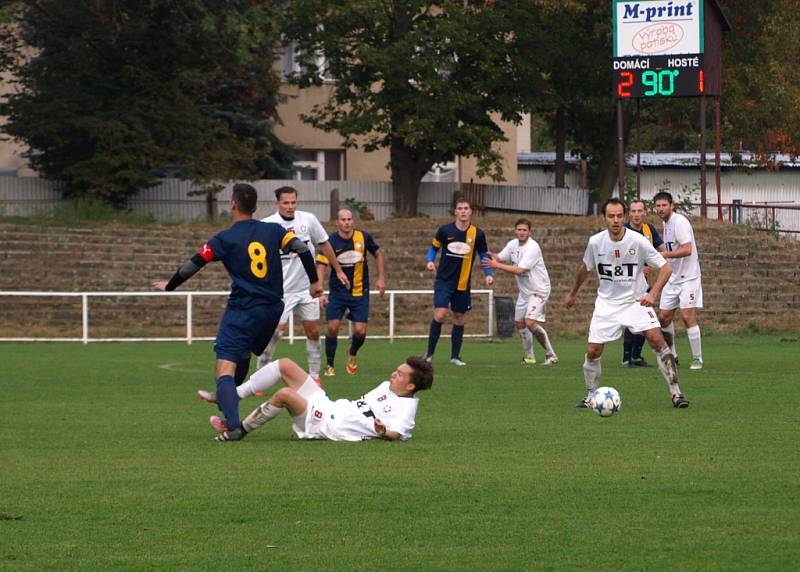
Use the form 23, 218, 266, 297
0, 334, 800, 570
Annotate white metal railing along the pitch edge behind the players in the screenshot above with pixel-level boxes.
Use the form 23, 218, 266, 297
0, 290, 494, 344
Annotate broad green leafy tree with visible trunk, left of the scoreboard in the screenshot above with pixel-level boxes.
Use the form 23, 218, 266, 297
284, 0, 541, 216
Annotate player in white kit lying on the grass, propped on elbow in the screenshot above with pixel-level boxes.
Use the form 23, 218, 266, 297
197, 357, 433, 441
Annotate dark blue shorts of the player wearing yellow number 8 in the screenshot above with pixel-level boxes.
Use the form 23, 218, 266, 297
214, 302, 283, 362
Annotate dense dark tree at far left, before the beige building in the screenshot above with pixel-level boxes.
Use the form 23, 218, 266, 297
0, 0, 291, 205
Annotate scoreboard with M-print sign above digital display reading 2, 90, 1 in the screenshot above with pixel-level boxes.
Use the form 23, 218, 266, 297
613, 0, 705, 99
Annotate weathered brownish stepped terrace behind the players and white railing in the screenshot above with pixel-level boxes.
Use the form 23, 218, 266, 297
0, 215, 800, 335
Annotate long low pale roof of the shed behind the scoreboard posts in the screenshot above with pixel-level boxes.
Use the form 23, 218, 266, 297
517, 151, 800, 169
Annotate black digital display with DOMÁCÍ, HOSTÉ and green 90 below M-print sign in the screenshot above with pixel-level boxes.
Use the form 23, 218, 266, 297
613, 54, 705, 99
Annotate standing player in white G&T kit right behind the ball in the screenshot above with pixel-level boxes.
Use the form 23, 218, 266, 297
564, 199, 689, 408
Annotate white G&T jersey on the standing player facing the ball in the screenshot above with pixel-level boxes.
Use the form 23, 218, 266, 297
583, 228, 667, 303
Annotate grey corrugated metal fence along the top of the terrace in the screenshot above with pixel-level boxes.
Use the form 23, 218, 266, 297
0, 177, 589, 221
